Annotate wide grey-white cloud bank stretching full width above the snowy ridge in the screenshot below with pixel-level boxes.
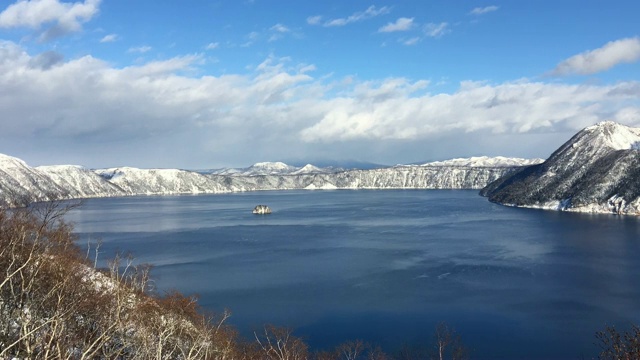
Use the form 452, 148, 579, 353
0, 41, 640, 167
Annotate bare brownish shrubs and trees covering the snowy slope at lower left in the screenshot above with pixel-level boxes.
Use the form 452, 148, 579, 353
0, 198, 237, 360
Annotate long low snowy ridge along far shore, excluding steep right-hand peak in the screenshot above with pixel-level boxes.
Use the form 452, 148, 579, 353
0, 155, 540, 206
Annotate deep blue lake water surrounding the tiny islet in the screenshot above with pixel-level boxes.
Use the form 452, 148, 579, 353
68, 190, 640, 359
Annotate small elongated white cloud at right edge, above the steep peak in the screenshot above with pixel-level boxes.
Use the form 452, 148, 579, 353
551, 37, 640, 76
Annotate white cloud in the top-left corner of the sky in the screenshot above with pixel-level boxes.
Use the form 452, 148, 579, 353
0, 0, 101, 41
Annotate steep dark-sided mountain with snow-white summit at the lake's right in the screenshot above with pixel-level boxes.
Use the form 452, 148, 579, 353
481, 122, 640, 214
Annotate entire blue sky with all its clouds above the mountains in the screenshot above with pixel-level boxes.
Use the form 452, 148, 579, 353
0, 0, 640, 169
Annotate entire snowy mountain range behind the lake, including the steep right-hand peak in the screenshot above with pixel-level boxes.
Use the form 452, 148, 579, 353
0, 122, 640, 214
